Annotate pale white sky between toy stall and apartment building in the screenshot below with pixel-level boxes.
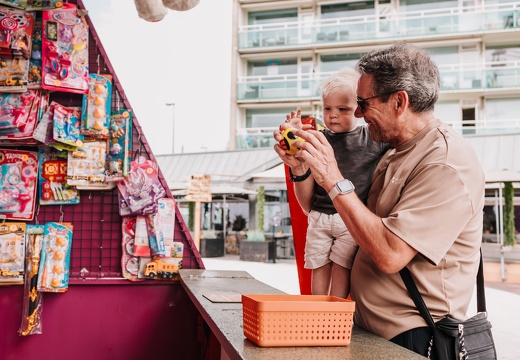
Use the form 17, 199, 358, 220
83, 0, 233, 155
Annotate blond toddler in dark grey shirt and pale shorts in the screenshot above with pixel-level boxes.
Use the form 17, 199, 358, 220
281, 69, 388, 298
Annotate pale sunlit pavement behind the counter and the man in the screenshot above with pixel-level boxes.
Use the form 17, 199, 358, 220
202, 255, 520, 360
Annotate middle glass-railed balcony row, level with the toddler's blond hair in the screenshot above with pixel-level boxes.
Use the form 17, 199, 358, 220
237, 60, 520, 103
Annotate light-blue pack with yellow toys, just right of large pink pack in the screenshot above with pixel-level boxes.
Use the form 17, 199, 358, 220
81, 74, 112, 138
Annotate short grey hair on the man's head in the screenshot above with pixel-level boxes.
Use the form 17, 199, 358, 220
356, 43, 440, 113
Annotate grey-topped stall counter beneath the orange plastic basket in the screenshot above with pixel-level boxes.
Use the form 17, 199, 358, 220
180, 269, 424, 360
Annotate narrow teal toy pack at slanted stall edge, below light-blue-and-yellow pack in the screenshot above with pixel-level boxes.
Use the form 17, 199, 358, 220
106, 110, 132, 182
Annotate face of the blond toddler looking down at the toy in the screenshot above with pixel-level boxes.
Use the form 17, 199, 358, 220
323, 90, 358, 133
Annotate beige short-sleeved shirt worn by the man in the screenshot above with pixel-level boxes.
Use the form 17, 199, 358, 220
351, 122, 485, 339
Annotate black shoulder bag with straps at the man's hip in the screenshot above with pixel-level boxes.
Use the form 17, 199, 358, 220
399, 251, 497, 360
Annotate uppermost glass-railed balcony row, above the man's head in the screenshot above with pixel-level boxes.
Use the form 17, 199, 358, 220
238, 2, 520, 52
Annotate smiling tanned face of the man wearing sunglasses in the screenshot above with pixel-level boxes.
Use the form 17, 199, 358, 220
355, 75, 397, 143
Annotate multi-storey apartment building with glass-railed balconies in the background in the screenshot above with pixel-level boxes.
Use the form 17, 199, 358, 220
230, 0, 520, 149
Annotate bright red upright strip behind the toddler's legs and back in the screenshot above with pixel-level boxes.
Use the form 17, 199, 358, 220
284, 165, 312, 295
